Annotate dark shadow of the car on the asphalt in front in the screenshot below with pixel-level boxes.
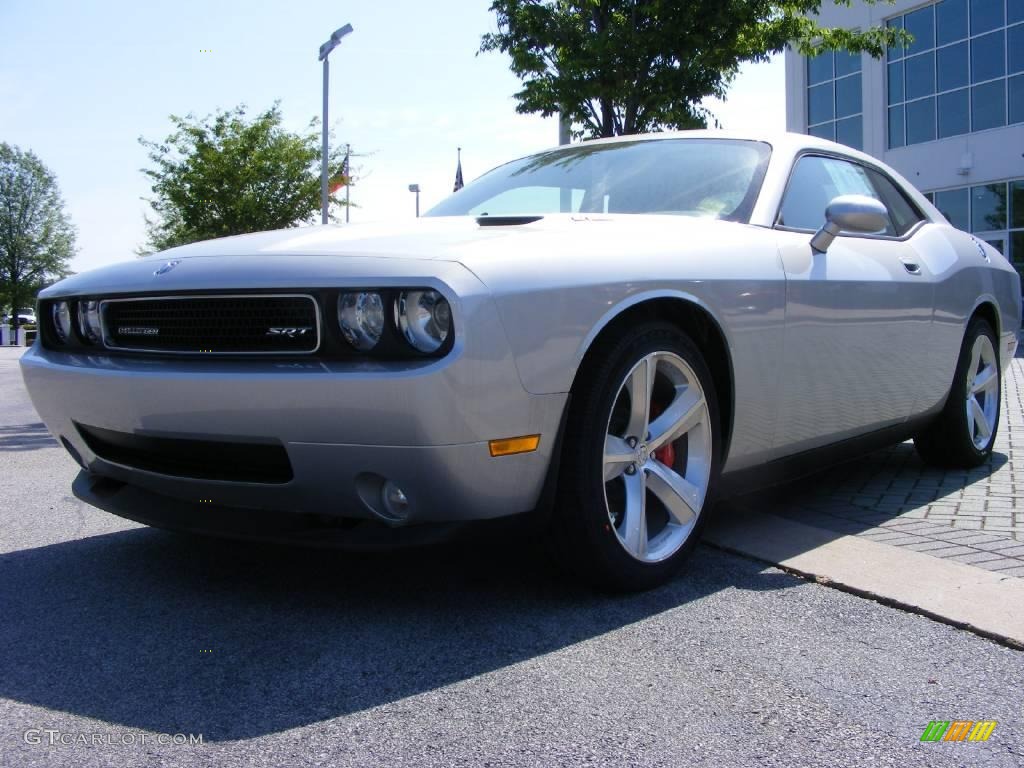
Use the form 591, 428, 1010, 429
0, 528, 801, 741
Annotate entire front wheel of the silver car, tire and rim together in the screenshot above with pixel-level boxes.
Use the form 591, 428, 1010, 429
553, 324, 720, 590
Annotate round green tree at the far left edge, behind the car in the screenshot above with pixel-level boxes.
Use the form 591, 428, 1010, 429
0, 143, 75, 328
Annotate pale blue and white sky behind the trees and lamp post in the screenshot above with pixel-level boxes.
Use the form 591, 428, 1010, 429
0, 0, 785, 271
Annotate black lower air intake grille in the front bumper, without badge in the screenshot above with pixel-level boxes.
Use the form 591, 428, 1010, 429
75, 424, 292, 483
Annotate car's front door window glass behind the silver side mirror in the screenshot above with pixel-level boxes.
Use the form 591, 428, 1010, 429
778, 155, 896, 234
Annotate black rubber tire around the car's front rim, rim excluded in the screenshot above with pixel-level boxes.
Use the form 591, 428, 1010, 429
549, 323, 721, 592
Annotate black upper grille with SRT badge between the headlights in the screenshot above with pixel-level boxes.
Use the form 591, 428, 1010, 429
101, 295, 319, 354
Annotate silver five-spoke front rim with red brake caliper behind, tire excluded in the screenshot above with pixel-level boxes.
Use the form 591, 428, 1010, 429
604, 352, 712, 562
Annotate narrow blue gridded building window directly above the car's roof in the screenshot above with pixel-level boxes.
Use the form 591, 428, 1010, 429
807, 51, 864, 150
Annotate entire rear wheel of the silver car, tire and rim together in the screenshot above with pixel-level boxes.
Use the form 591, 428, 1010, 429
913, 317, 1002, 467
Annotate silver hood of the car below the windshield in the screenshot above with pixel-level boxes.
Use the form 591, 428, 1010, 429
41, 214, 750, 298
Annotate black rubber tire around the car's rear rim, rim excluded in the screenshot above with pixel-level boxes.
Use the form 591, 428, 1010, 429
913, 317, 1002, 468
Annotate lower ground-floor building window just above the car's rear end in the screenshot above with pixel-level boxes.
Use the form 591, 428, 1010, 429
925, 179, 1024, 274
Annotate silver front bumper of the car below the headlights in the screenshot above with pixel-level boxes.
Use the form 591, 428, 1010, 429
22, 282, 567, 529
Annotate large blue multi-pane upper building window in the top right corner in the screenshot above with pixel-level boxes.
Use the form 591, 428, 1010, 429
886, 0, 1024, 150
